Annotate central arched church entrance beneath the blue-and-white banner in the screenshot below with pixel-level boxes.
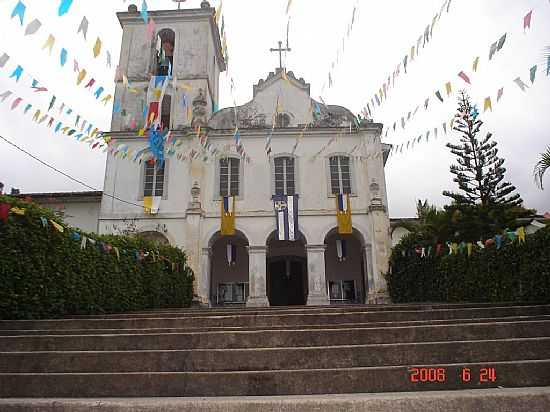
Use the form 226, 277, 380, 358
267, 232, 308, 306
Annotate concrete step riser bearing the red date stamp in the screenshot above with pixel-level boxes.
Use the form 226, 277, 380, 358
0, 360, 550, 398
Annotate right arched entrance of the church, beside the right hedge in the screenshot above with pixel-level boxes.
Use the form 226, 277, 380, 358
325, 229, 367, 304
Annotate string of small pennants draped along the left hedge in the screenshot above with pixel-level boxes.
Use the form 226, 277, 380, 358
0, 202, 179, 272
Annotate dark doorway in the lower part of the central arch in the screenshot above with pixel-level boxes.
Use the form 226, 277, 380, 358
267, 257, 306, 306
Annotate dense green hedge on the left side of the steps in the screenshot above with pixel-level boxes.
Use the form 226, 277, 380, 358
0, 196, 193, 319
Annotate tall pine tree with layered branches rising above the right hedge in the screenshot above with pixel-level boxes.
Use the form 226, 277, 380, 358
443, 92, 523, 207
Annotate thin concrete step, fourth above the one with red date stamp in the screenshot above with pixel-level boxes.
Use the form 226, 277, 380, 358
0, 305, 550, 330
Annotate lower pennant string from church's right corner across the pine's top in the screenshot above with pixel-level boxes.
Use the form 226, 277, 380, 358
390, 59, 550, 157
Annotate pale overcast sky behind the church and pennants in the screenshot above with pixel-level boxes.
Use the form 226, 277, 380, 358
0, 0, 550, 217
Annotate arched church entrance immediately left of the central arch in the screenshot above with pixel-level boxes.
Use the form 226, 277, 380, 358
210, 231, 249, 306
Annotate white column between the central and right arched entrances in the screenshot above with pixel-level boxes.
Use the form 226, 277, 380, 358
306, 245, 330, 306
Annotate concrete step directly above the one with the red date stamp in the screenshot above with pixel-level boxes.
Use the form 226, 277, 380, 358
0, 337, 550, 373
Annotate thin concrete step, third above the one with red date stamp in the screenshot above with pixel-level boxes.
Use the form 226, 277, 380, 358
0, 315, 550, 336
